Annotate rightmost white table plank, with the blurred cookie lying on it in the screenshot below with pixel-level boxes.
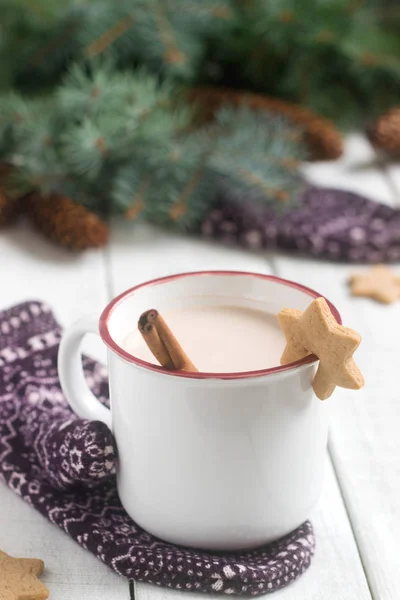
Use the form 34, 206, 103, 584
275, 140, 400, 600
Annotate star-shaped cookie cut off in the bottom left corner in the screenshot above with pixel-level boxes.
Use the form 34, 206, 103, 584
0, 551, 49, 600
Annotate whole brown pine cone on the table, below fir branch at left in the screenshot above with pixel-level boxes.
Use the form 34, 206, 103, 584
25, 194, 108, 250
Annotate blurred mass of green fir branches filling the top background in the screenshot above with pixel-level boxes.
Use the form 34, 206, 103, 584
0, 0, 400, 247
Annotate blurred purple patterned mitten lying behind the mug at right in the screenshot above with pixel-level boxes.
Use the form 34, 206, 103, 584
201, 186, 400, 263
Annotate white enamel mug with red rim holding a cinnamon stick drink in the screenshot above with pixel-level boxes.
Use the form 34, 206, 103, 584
59, 271, 341, 550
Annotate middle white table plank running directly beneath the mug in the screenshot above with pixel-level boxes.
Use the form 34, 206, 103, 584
108, 223, 371, 600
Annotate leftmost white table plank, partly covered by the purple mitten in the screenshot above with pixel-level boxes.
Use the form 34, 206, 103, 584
0, 224, 129, 600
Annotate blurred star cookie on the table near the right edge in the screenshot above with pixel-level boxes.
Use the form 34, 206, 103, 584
349, 265, 400, 304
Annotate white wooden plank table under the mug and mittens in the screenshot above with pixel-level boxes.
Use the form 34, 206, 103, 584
0, 136, 400, 600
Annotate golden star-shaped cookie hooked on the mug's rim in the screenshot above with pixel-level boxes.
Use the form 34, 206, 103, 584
278, 298, 364, 400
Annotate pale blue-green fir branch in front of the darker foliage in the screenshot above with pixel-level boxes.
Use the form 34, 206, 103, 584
1, 65, 304, 230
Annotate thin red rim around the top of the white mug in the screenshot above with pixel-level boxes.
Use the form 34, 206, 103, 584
99, 271, 342, 379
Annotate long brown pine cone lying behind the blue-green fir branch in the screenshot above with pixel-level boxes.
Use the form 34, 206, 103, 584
189, 88, 343, 160
